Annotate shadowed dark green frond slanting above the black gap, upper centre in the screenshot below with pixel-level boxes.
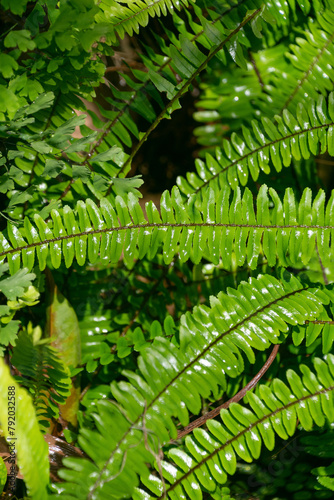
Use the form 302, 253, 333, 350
81, 0, 263, 177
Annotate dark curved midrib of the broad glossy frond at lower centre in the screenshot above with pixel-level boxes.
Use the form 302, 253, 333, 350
88, 288, 307, 499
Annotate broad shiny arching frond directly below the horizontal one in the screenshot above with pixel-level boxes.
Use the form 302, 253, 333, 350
55, 275, 328, 499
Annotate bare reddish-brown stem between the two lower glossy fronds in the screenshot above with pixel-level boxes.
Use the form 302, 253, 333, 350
177, 344, 279, 439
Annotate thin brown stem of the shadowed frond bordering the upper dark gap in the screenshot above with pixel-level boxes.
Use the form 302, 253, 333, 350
115, 9, 261, 180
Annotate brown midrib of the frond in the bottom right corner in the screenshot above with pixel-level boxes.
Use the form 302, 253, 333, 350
160, 386, 334, 500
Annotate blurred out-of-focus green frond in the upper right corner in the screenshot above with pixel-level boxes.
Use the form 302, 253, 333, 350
194, 6, 334, 147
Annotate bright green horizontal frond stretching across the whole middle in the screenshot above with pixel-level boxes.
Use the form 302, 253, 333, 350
0, 185, 334, 273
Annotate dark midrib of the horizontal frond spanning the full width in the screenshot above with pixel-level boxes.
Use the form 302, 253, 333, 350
0, 222, 334, 257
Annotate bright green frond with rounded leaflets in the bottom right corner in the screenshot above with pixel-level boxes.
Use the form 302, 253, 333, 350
133, 354, 334, 500
